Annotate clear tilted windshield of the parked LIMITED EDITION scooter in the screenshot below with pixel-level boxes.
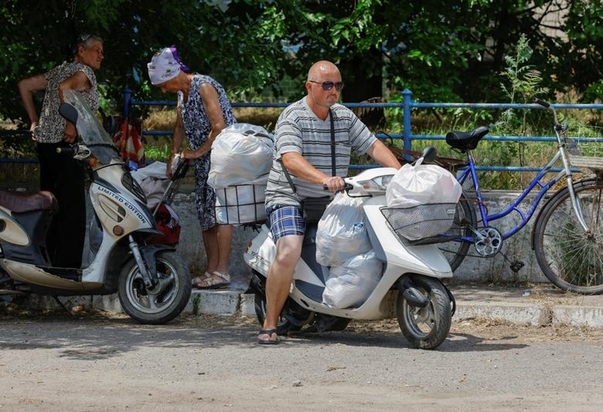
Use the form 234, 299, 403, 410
63, 89, 119, 164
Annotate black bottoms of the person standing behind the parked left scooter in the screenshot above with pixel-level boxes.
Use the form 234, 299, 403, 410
37, 142, 86, 268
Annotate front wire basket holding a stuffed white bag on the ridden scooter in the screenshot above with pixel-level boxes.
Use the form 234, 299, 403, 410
381, 159, 462, 244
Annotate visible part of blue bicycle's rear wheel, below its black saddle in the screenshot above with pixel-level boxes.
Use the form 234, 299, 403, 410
438, 191, 477, 272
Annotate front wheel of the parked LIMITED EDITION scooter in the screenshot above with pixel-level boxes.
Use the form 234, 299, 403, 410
117, 250, 192, 325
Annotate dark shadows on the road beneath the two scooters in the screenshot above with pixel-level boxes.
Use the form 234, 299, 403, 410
0, 313, 527, 360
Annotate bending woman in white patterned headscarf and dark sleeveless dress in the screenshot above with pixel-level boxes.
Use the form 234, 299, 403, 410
147, 46, 236, 288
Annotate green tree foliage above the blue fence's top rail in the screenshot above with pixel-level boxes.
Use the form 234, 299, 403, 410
0, 0, 603, 125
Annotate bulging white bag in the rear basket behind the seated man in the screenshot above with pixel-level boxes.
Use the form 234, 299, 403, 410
207, 123, 274, 189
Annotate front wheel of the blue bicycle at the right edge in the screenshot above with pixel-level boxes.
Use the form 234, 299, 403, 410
533, 180, 603, 295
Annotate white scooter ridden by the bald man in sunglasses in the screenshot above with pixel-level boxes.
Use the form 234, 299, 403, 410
244, 148, 455, 349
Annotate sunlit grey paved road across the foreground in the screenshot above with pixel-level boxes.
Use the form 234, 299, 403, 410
0, 314, 603, 412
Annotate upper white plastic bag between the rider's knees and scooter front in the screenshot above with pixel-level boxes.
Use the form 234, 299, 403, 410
316, 193, 372, 266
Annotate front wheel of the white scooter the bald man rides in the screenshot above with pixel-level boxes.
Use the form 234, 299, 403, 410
396, 276, 452, 349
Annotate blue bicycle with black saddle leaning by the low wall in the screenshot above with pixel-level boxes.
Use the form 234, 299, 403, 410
404, 100, 603, 294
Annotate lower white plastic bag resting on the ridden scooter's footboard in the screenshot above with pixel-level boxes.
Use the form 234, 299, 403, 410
322, 250, 383, 308
